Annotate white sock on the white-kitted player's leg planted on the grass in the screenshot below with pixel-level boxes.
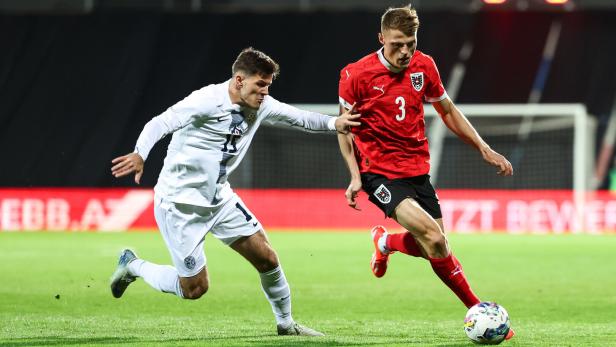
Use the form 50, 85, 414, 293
259, 265, 293, 327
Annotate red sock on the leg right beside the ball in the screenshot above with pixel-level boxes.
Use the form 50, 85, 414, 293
428, 254, 481, 308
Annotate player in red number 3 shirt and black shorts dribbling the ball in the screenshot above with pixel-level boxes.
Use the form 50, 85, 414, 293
338, 7, 513, 337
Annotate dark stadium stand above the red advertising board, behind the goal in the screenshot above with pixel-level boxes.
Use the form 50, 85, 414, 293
0, 11, 616, 187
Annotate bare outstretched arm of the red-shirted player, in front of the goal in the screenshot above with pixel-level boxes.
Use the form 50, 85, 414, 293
432, 97, 513, 176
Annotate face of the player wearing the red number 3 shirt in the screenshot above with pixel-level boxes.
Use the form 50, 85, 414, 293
379, 29, 417, 69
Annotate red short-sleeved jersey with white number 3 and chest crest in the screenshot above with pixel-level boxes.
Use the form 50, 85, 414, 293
338, 49, 447, 179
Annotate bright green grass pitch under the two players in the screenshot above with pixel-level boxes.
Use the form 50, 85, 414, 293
0, 232, 616, 346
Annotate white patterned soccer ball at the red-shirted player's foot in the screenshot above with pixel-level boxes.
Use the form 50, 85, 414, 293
464, 302, 511, 345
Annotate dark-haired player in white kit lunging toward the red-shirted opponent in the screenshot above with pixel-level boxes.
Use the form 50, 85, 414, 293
111, 48, 360, 336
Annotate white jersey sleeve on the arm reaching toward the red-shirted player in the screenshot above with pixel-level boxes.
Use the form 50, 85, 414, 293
262, 96, 336, 132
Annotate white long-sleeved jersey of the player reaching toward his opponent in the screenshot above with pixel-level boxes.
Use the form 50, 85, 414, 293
135, 81, 335, 207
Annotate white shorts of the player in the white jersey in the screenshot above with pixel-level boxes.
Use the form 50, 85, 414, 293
154, 193, 262, 277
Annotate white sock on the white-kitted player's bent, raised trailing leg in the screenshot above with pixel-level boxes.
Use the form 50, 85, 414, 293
128, 259, 184, 298
